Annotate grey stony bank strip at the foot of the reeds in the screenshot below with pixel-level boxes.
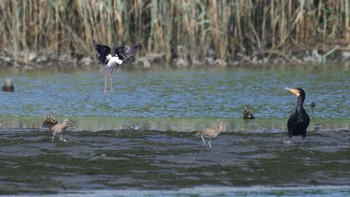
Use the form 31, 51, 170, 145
0, 46, 350, 71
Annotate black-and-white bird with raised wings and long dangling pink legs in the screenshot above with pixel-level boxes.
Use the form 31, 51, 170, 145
96, 44, 142, 94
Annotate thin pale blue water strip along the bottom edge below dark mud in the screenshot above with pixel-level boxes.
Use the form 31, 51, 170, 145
21, 186, 349, 197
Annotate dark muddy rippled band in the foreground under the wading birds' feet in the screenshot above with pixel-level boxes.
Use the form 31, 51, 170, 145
0, 126, 350, 194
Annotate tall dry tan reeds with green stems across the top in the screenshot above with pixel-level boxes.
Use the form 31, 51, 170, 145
0, 0, 350, 66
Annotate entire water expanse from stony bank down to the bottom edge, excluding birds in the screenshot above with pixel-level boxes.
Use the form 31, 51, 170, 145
0, 66, 350, 196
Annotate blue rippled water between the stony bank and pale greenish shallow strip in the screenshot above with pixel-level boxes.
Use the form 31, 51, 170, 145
0, 69, 350, 119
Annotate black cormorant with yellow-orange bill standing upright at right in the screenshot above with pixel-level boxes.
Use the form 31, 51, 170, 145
285, 88, 310, 138
